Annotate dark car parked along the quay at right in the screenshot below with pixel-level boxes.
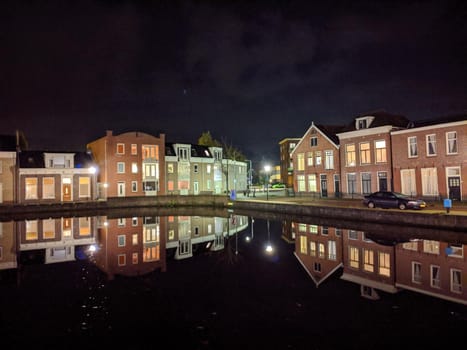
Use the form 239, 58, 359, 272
363, 191, 426, 210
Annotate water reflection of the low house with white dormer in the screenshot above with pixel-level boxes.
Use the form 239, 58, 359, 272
15, 217, 97, 264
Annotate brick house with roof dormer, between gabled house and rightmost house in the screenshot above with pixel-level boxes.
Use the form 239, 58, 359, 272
337, 111, 409, 197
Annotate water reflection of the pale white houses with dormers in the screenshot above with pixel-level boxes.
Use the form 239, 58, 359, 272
166, 215, 248, 259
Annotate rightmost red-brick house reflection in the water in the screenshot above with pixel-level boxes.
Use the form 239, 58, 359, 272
396, 240, 467, 304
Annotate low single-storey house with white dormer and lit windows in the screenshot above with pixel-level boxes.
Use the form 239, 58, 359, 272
17, 151, 96, 203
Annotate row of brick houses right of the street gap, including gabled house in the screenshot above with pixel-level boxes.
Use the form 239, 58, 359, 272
279, 111, 467, 200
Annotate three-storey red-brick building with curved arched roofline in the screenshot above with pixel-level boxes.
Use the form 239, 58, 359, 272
87, 130, 166, 199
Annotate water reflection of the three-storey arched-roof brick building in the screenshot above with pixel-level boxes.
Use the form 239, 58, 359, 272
93, 216, 166, 279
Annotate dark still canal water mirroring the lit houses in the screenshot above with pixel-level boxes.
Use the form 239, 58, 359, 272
0, 210, 467, 349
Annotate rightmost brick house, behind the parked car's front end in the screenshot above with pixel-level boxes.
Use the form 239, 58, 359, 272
391, 116, 467, 200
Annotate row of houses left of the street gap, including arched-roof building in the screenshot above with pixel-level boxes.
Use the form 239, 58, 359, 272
0, 130, 247, 203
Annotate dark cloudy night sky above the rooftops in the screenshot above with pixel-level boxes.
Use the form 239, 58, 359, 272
0, 0, 467, 162
